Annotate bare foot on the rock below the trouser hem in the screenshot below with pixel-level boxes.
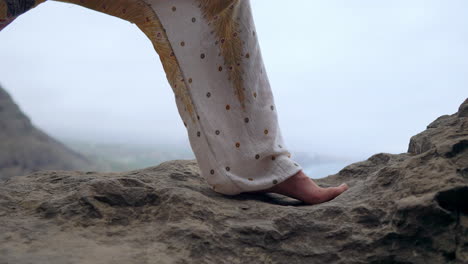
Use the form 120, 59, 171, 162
245, 170, 348, 204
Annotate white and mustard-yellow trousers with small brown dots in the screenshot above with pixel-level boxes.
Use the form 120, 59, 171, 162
0, 0, 302, 195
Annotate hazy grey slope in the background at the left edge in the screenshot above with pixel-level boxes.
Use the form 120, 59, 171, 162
0, 87, 96, 179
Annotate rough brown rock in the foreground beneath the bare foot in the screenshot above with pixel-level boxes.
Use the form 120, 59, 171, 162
0, 100, 468, 264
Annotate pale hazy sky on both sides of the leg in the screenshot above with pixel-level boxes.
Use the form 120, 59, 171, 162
0, 0, 468, 159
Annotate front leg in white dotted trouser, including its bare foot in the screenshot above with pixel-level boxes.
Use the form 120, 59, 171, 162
149, 0, 347, 204
